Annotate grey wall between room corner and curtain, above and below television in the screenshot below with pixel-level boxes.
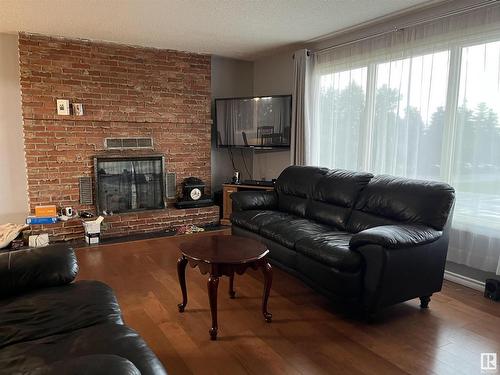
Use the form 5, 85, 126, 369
253, 51, 293, 180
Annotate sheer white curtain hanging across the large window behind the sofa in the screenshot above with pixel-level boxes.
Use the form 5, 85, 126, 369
305, 6, 500, 274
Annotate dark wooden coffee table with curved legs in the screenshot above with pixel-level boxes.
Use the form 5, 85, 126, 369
177, 235, 273, 340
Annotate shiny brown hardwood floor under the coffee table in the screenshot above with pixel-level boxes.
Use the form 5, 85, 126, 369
77, 233, 500, 375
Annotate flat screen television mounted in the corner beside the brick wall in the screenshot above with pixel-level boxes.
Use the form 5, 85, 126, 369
215, 95, 292, 149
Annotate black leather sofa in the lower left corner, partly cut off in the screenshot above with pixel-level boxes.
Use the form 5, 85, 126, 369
0, 245, 166, 375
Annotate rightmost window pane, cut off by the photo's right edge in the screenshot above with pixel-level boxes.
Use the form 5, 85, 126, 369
450, 41, 500, 230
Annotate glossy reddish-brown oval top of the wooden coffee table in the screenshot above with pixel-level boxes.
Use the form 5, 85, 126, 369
179, 235, 269, 264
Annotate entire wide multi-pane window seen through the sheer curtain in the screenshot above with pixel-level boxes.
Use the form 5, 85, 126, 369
314, 41, 500, 229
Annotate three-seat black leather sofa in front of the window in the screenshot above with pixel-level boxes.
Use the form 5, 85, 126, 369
231, 166, 455, 313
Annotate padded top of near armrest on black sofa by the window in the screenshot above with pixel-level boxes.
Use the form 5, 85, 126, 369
349, 225, 443, 249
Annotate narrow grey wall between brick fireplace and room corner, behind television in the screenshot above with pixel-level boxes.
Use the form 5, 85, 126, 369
212, 56, 254, 191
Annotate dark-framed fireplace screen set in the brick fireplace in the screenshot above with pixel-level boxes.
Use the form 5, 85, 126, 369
94, 156, 165, 214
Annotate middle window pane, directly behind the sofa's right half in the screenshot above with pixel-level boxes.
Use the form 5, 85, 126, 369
368, 51, 449, 178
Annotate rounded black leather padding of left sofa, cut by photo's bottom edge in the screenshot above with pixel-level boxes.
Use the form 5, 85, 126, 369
30, 354, 141, 375
